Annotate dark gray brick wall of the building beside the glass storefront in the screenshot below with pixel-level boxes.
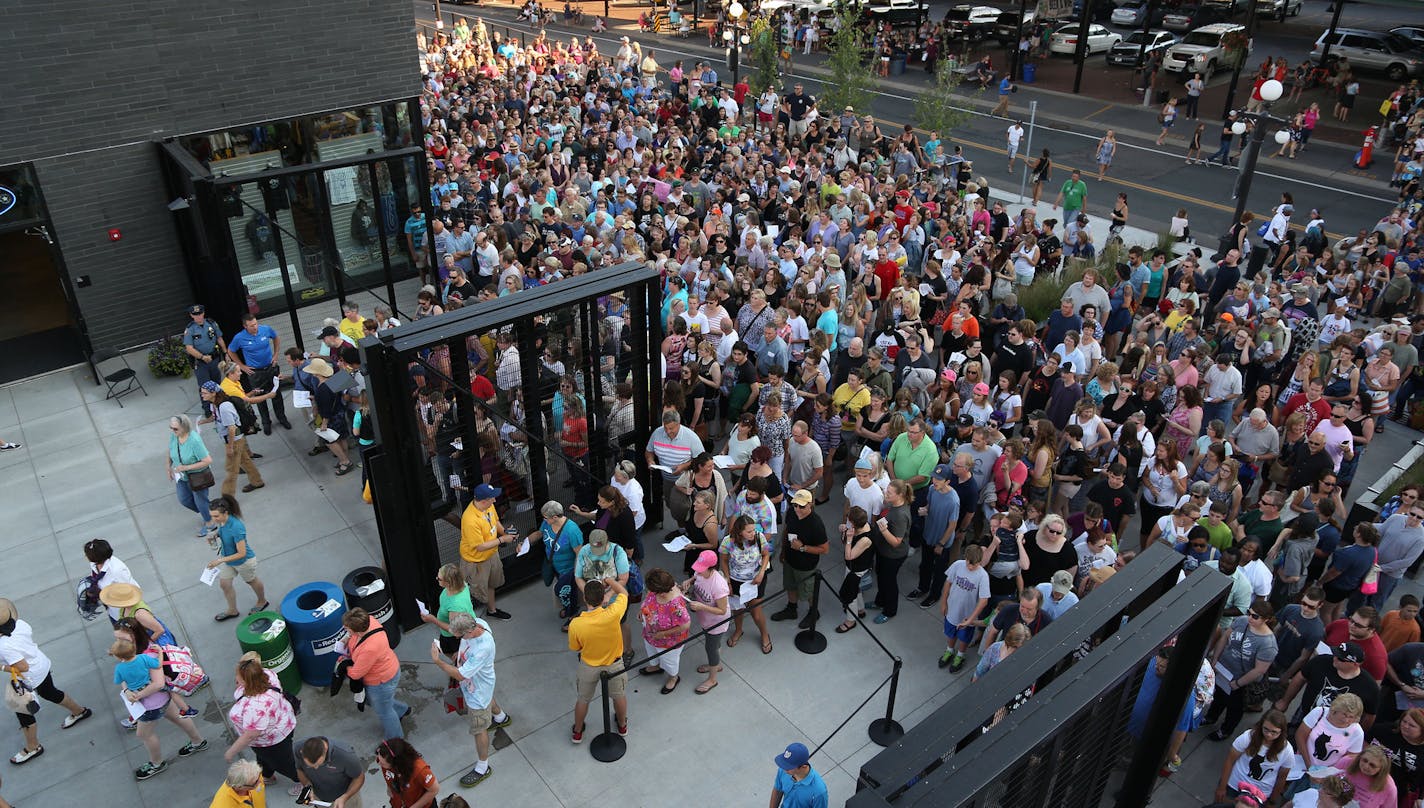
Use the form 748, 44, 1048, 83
0, 0, 420, 346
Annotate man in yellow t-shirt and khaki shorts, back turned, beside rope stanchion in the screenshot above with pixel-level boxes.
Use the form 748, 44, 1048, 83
568, 579, 628, 744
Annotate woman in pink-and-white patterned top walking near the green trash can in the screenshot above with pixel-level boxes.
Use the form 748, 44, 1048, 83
222, 651, 302, 797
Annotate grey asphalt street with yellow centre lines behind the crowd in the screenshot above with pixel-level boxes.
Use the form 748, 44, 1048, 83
416, 0, 1407, 239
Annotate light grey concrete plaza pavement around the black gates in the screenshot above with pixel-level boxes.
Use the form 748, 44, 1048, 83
0, 336, 1420, 808
